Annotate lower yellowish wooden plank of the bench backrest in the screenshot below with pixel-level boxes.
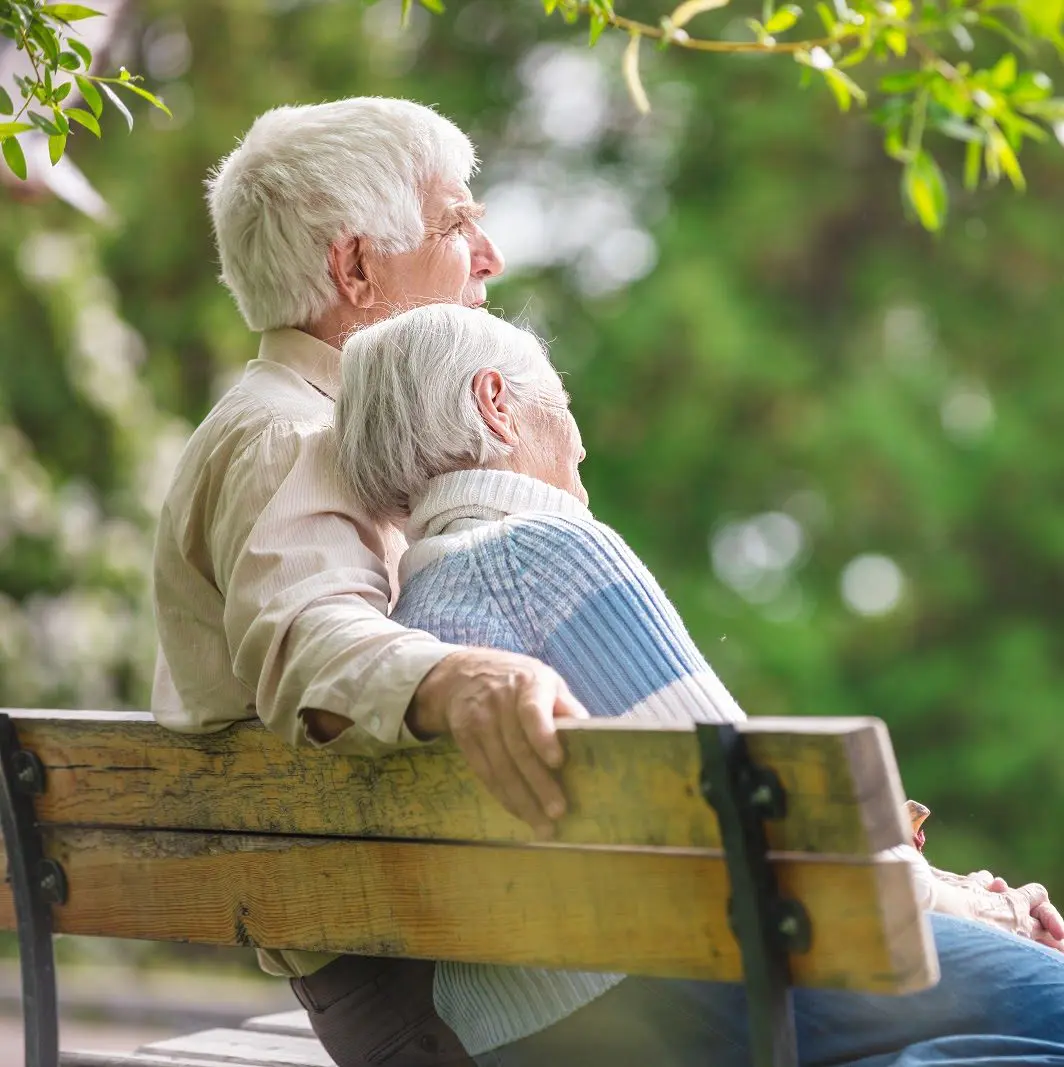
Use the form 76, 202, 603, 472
0, 827, 936, 992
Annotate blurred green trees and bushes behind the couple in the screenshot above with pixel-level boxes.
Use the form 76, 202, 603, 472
0, 0, 1064, 899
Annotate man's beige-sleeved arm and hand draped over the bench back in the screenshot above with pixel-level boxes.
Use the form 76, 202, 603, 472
212, 431, 587, 837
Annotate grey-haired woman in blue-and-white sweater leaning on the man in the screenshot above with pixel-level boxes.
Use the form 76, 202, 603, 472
336, 304, 1064, 1067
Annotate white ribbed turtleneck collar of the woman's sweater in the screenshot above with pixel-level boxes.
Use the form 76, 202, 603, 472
407, 471, 591, 542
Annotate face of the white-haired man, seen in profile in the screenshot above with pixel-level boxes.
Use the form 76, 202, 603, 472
366, 181, 504, 312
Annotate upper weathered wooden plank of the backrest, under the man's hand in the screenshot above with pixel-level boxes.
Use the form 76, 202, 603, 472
11, 712, 910, 856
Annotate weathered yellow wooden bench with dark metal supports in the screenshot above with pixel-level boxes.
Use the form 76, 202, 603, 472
0, 711, 937, 1067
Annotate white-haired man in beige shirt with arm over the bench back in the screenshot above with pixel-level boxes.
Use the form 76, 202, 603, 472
152, 99, 585, 1067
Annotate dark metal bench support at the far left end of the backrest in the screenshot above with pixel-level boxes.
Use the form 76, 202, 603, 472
0, 714, 66, 1067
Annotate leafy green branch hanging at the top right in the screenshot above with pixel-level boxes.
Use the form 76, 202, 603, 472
542, 0, 1064, 230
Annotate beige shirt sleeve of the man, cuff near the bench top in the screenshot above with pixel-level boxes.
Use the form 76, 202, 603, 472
209, 425, 455, 754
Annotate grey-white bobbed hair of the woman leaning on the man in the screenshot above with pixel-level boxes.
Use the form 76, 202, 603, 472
336, 304, 565, 522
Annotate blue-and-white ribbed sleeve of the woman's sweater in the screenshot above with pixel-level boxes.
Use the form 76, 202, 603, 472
493, 515, 746, 722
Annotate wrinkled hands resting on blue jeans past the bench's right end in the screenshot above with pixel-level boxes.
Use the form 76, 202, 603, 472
905, 800, 1064, 952
